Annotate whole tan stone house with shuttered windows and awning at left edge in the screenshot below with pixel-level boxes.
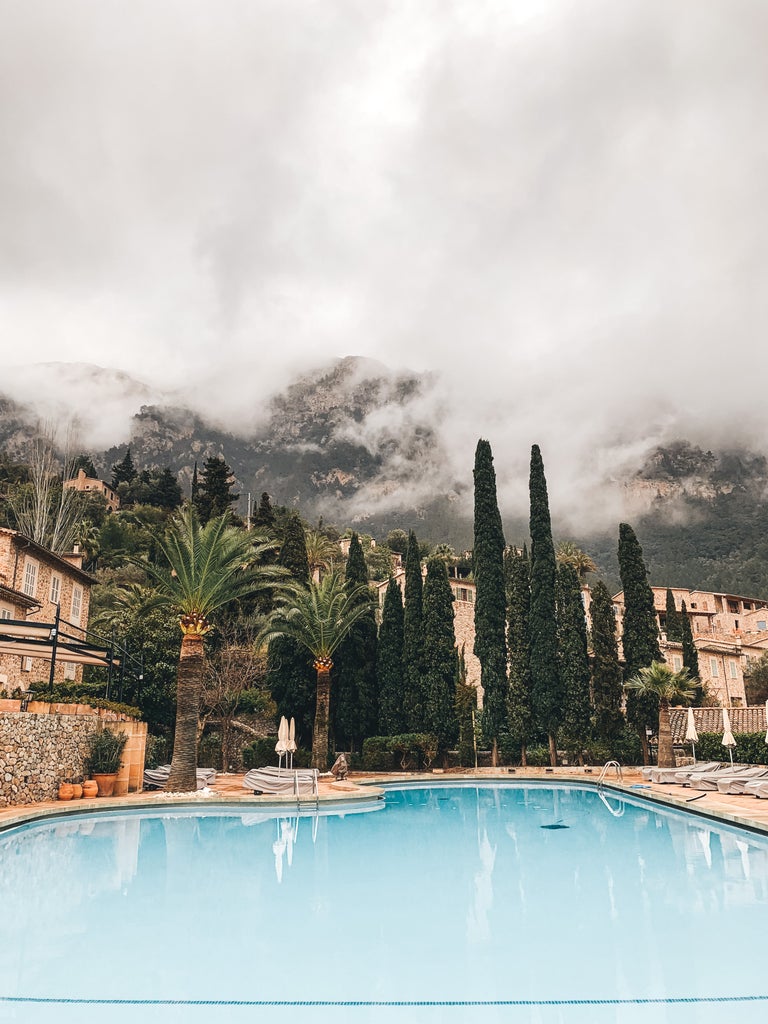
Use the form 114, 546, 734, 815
0, 527, 94, 692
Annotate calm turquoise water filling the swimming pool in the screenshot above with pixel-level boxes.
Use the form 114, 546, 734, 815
0, 782, 768, 1024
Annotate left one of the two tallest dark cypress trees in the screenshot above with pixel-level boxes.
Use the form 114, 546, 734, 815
472, 438, 507, 766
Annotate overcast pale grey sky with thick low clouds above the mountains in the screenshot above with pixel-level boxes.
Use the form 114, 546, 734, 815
0, 0, 768, 520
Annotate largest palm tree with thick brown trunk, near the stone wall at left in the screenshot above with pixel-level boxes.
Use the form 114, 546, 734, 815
139, 504, 291, 792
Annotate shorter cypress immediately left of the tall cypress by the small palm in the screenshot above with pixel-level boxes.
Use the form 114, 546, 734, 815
590, 582, 624, 744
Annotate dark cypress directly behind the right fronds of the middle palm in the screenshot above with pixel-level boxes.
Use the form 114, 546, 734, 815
331, 534, 379, 750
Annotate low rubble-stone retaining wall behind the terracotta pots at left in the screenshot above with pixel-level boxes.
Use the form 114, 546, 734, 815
0, 700, 146, 807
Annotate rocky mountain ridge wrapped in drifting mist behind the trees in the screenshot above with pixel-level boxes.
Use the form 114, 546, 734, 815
0, 356, 768, 597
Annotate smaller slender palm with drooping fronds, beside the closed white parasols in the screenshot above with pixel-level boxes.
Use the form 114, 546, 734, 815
261, 569, 371, 771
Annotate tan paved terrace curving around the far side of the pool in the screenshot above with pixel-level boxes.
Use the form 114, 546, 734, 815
0, 768, 768, 834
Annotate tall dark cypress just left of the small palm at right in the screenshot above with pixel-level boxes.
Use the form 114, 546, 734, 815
618, 522, 662, 764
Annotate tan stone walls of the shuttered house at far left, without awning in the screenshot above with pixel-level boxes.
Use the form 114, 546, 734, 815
0, 527, 93, 693
